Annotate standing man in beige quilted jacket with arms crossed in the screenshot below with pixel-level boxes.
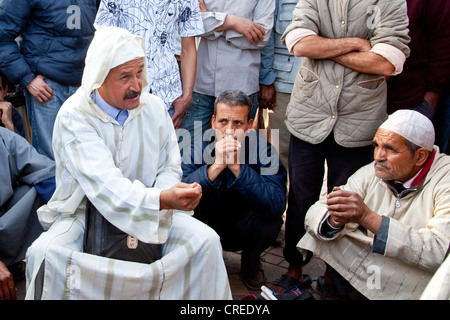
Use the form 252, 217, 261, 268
272, 0, 410, 292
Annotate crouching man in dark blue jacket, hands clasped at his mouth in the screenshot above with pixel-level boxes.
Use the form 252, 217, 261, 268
182, 91, 287, 290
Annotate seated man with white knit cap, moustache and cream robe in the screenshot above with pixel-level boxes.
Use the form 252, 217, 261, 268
298, 110, 450, 299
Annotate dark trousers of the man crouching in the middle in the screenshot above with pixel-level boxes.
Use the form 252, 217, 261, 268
194, 209, 283, 275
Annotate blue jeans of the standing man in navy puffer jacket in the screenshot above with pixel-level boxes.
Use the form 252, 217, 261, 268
24, 78, 78, 159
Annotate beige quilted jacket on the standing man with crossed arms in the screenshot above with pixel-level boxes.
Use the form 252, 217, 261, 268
282, 0, 410, 148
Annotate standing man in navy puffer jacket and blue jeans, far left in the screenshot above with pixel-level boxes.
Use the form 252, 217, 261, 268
0, 0, 100, 159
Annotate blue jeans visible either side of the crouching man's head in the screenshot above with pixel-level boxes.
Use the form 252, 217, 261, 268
181, 92, 258, 137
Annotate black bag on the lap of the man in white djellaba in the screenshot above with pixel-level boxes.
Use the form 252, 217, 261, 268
83, 200, 162, 264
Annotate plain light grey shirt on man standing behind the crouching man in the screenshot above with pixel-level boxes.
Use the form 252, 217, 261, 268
194, 0, 275, 97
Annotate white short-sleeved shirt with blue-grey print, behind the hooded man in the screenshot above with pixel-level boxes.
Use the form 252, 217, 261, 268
95, 0, 204, 109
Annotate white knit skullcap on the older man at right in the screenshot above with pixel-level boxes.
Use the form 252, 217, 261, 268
380, 110, 434, 151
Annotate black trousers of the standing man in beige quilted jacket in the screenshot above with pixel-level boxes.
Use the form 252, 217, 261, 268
283, 133, 372, 266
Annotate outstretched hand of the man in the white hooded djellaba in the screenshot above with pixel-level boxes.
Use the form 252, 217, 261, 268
159, 182, 202, 211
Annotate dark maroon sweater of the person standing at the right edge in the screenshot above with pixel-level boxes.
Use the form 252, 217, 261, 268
388, 0, 450, 113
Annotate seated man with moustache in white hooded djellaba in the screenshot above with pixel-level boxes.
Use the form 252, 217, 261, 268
25, 27, 231, 300
